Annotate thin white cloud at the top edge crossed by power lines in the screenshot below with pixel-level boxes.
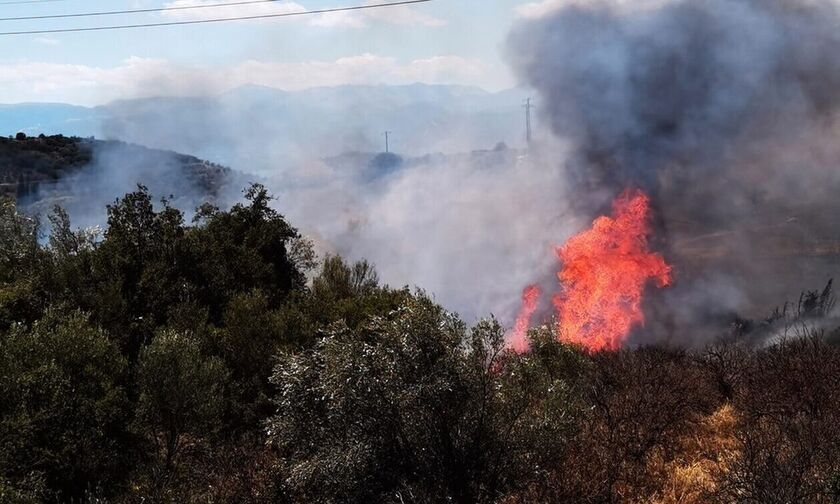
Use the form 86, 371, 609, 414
163, 0, 446, 28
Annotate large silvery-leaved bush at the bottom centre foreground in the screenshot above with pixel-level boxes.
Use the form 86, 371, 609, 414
268, 295, 575, 503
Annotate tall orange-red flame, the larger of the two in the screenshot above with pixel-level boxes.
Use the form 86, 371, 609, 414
554, 190, 671, 351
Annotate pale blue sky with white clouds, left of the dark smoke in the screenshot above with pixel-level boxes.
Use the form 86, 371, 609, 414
0, 0, 561, 106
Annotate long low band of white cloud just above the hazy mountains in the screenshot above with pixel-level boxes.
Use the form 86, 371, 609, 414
0, 54, 494, 105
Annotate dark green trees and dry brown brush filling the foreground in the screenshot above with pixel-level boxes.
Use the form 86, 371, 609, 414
0, 186, 840, 504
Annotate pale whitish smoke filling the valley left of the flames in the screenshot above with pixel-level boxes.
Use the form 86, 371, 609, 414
275, 149, 583, 324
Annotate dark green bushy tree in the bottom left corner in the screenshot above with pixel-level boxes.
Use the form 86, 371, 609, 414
0, 309, 133, 499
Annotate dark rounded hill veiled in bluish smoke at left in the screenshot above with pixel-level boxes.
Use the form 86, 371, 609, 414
0, 134, 247, 225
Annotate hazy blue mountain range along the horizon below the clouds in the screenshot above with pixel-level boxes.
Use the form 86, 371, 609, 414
0, 84, 527, 174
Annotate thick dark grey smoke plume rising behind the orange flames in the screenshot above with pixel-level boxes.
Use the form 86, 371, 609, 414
510, 0, 840, 344
